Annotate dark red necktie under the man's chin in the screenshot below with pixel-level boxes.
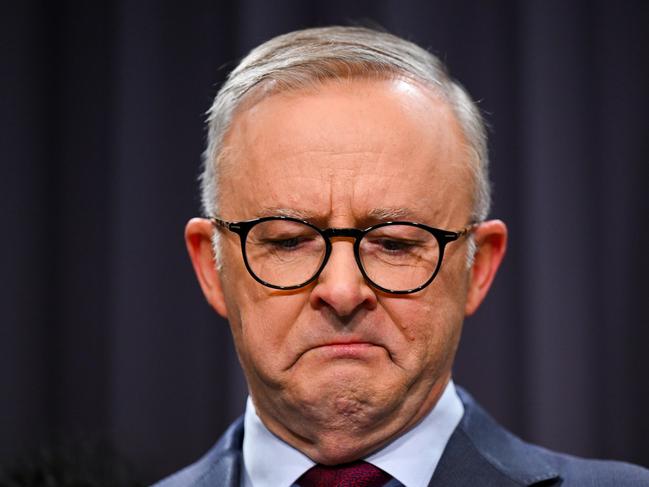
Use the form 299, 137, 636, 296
297, 461, 392, 487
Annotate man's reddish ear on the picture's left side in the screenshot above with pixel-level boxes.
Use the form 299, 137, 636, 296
185, 218, 228, 318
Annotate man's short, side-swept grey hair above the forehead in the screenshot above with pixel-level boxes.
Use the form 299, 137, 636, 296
200, 27, 491, 266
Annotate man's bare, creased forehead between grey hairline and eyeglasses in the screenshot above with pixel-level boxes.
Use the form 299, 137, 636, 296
220, 79, 472, 223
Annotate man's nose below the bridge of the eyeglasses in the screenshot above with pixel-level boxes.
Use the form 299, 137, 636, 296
309, 240, 377, 317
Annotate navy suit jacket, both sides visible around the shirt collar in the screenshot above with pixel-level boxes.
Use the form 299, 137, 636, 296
155, 387, 649, 487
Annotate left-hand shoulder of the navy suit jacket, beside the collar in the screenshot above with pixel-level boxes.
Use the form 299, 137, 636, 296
153, 417, 243, 487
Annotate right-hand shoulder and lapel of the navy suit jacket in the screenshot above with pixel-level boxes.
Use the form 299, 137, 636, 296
434, 388, 649, 487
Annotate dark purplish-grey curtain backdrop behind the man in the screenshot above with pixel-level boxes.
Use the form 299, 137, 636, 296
0, 0, 649, 481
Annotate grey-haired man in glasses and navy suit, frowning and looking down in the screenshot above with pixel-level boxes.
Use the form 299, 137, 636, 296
159, 27, 649, 487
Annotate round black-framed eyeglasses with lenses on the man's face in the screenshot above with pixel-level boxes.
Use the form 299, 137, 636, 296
209, 216, 476, 294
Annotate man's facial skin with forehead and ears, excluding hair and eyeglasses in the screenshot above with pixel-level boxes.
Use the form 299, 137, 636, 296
186, 79, 506, 464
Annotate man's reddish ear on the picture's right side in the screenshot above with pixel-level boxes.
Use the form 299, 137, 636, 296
464, 220, 507, 316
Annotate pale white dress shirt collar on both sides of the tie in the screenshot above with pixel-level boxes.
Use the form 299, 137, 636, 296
241, 381, 464, 487
